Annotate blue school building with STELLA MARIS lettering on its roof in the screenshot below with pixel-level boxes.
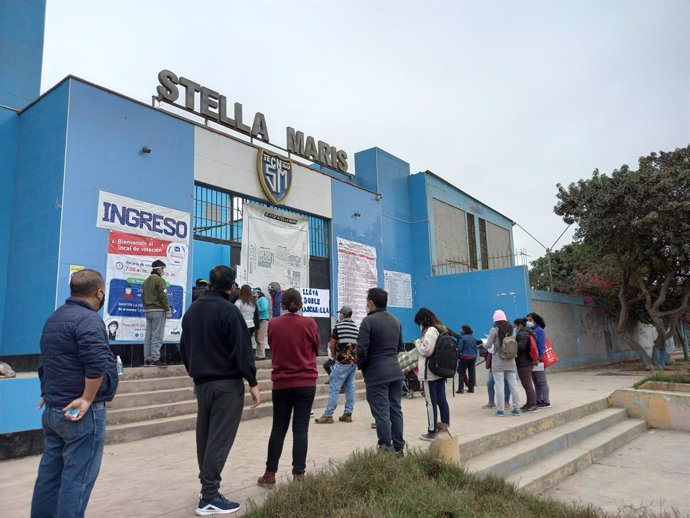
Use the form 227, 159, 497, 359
0, 0, 636, 452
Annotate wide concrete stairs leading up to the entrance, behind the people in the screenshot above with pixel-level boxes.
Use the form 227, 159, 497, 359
106, 357, 365, 444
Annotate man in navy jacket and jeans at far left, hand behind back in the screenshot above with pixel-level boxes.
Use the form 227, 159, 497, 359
31, 269, 118, 518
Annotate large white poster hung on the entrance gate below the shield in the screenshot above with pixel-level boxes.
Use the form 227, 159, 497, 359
240, 203, 309, 290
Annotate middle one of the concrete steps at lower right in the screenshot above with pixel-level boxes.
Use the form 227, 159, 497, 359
461, 408, 628, 477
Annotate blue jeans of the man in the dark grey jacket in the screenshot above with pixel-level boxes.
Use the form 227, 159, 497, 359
367, 380, 405, 451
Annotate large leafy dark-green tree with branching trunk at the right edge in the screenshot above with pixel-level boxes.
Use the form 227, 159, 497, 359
554, 146, 690, 368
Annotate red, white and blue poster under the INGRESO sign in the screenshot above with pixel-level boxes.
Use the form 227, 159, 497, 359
103, 231, 189, 341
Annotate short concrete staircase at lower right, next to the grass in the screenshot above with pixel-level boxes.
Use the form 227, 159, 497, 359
460, 399, 647, 493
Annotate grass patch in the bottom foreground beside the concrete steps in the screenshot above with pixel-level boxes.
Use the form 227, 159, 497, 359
247, 450, 605, 518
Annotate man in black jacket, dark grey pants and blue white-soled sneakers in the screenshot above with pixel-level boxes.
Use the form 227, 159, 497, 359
180, 266, 261, 516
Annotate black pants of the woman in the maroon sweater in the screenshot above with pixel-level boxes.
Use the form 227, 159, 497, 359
266, 387, 316, 475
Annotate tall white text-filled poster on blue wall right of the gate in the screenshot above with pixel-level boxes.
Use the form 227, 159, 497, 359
337, 237, 378, 325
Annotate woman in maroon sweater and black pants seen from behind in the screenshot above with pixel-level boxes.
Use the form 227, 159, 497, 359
258, 288, 321, 488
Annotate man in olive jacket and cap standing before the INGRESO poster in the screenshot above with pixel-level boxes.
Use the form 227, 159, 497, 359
142, 259, 172, 367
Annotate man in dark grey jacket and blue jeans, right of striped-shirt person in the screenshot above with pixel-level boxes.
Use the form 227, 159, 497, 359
357, 288, 405, 455
